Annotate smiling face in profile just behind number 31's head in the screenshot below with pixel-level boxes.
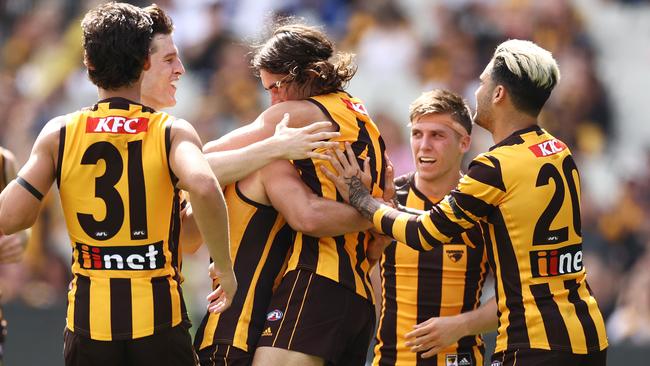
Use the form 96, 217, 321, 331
141, 34, 185, 109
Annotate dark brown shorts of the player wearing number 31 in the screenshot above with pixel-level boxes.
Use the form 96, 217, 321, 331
63, 325, 198, 366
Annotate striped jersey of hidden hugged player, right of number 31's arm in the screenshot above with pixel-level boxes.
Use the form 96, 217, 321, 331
194, 184, 292, 352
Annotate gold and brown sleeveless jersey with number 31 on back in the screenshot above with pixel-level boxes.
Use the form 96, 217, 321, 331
56, 98, 188, 341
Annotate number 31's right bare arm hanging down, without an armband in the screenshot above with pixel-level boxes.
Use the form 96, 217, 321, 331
170, 120, 237, 312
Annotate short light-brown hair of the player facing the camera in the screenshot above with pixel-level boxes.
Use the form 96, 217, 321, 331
409, 89, 472, 134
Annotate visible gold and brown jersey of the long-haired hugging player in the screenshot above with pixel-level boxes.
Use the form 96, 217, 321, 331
287, 91, 386, 301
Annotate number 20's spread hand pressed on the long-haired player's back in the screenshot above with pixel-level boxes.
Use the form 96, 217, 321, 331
321, 142, 372, 202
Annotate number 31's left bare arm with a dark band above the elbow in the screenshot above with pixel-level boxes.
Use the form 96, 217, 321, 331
0, 117, 63, 234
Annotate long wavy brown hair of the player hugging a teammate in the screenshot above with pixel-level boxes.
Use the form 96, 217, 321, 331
251, 18, 357, 95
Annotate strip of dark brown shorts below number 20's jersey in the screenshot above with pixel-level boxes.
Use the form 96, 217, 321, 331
490, 349, 607, 366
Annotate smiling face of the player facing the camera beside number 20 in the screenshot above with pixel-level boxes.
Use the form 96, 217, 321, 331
411, 113, 469, 182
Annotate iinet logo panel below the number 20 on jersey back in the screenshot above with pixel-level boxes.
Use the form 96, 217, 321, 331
530, 244, 582, 277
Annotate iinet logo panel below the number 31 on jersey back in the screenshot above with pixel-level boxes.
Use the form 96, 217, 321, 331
77, 241, 165, 271
